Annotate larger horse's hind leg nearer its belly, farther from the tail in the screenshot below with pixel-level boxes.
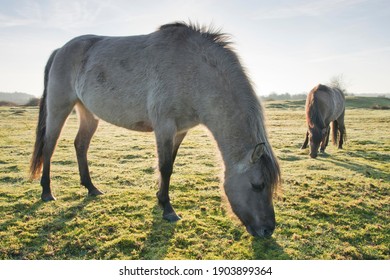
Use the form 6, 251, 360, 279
74, 103, 103, 196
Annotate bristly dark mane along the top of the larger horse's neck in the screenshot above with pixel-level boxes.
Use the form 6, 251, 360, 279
159, 22, 232, 48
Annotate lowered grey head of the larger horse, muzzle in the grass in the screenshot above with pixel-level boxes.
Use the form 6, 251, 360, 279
224, 143, 280, 237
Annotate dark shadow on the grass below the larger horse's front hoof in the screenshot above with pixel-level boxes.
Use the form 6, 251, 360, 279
139, 205, 177, 260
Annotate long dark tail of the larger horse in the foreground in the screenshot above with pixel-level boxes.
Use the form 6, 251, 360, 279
30, 49, 58, 179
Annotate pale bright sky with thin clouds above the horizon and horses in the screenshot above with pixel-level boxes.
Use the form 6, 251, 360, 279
0, 0, 390, 96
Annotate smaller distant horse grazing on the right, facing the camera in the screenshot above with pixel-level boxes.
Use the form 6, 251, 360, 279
302, 84, 346, 158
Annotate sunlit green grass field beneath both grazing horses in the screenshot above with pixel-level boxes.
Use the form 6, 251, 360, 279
0, 98, 390, 259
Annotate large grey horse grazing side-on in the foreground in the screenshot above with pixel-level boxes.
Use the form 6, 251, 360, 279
30, 23, 280, 236
